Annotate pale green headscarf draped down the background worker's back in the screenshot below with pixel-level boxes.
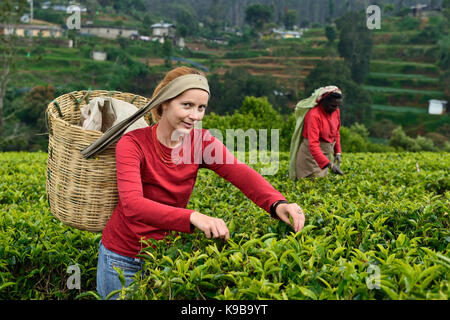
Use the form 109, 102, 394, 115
289, 86, 342, 180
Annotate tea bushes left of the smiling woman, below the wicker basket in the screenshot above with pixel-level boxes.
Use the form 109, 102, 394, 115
0, 152, 100, 299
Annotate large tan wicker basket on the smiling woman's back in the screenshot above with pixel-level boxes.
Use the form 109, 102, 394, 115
46, 90, 149, 232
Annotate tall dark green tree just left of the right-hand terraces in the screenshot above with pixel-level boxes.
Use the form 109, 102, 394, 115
336, 12, 373, 83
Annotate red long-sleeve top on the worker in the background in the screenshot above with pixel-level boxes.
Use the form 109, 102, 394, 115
302, 104, 341, 169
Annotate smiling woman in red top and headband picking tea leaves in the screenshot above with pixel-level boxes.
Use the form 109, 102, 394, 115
97, 67, 305, 298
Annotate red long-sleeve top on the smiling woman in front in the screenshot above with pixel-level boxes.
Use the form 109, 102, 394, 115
102, 127, 286, 257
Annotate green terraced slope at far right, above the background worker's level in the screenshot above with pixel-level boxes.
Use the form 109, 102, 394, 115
364, 18, 448, 134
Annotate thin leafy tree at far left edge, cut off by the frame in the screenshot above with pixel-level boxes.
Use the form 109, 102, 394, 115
0, 0, 28, 138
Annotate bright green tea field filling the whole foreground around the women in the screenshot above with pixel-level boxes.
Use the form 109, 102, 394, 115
0, 153, 450, 300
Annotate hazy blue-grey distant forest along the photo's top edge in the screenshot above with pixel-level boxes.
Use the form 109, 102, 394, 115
75, 0, 442, 26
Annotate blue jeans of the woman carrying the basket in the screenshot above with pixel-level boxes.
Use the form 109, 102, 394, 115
97, 240, 142, 299
